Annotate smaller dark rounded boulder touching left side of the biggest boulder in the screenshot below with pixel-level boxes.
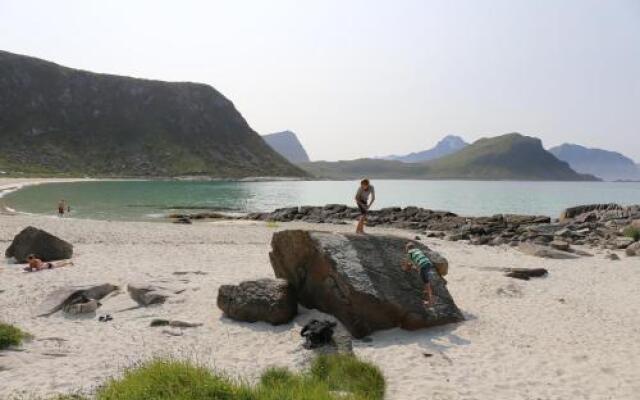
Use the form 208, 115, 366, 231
218, 279, 298, 325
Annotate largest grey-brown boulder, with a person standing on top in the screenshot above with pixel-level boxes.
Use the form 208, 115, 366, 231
270, 230, 464, 338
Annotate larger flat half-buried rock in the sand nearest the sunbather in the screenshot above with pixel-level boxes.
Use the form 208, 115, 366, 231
38, 283, 118, 317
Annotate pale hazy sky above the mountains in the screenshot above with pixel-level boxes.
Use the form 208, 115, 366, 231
0, 0, 640, 162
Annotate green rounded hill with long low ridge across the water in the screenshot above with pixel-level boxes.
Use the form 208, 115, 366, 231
299, 133, 596, 181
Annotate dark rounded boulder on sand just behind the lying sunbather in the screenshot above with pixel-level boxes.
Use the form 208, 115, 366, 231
5, 226, 73, 263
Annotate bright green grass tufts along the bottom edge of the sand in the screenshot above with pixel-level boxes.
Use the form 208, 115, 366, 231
87, 355, 385, 400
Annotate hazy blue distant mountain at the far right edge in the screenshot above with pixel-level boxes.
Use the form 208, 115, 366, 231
549, 143, 640, 181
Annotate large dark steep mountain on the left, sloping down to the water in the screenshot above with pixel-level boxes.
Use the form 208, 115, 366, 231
0, 51, 306, 178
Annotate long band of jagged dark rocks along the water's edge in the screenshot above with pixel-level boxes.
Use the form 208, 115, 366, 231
236, 204, 640, 258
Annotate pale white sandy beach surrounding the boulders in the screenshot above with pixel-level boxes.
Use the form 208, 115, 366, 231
0, 180, 640, 399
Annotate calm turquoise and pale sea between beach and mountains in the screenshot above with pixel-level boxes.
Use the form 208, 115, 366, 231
0, 180, 640, 220
